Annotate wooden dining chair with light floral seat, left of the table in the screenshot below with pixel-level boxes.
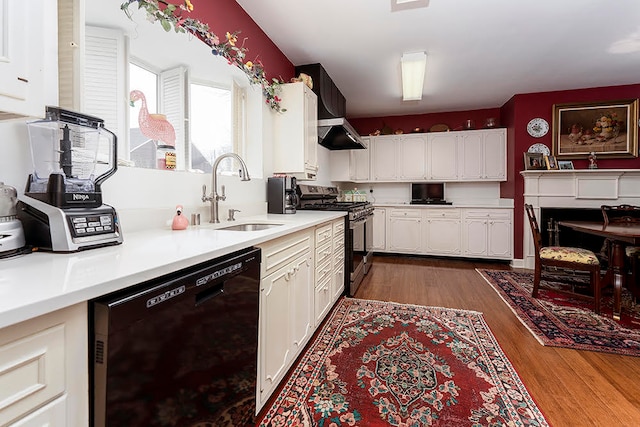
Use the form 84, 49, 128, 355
524, 204, 601, 314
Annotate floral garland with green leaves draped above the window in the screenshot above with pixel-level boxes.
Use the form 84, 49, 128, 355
120, 0, 286, 112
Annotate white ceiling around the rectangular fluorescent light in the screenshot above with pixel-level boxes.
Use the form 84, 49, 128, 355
238, 0, 640, 117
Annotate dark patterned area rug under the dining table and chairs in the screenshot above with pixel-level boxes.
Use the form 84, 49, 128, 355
477, 269, 640, 356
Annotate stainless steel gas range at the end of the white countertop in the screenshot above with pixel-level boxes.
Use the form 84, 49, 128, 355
297, 184, 373, 296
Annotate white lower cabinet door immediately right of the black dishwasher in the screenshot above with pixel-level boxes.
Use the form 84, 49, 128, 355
259, 265, 292, 403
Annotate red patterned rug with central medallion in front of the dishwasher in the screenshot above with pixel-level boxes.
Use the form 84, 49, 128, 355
259, 298, 548, 427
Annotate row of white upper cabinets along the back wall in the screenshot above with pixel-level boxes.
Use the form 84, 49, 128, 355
338, 129, 507, 182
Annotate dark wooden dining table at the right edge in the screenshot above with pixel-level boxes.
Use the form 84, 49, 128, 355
558, 221, 640, 320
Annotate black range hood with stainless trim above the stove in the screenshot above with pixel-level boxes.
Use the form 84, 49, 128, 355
295, 64, 367, 150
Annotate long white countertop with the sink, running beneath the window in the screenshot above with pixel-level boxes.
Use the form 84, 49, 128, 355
0, 211, 345, 328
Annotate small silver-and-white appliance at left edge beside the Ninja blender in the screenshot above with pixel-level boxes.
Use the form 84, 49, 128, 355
0, 182, 25, 258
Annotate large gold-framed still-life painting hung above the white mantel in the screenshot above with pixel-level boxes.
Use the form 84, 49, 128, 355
553, 99, 638, 159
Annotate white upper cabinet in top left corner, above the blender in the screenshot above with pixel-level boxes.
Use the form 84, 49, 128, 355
0, 0, 58, 120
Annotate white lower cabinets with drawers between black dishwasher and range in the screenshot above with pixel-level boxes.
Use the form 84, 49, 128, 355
256, 218, 345, 410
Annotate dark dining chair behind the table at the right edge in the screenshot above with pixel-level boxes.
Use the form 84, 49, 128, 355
600, 204, 640, 300
